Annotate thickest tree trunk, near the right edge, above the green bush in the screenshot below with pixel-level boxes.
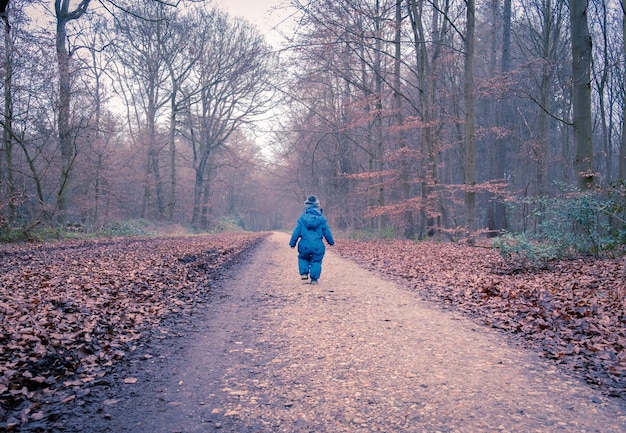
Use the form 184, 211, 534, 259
570, 0, 594, 191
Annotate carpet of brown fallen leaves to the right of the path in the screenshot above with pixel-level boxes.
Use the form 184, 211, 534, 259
337, 240, 626, 398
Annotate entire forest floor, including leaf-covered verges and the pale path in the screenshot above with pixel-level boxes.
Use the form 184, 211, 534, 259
0, 233, 626, 433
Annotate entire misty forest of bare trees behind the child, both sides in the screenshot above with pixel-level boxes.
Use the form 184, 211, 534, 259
0, 0, 626, 251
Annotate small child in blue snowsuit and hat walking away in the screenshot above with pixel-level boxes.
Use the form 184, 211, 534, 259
289, 195, 335, 284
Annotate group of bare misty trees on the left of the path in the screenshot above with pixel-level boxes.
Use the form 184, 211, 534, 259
0, 0, 276, 231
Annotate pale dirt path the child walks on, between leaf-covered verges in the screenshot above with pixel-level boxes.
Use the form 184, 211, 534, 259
97, 233, 626, 433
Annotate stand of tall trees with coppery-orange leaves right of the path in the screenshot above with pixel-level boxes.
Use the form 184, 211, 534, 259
286, 0, 624, 237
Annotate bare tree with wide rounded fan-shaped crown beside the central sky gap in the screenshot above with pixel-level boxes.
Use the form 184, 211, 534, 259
185, 10, 275, 228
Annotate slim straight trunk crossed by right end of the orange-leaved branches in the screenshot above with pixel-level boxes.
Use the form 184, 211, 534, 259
463, 0, 476, 233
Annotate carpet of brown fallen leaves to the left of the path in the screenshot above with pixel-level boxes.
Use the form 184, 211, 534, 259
0, 234, 262, 429
